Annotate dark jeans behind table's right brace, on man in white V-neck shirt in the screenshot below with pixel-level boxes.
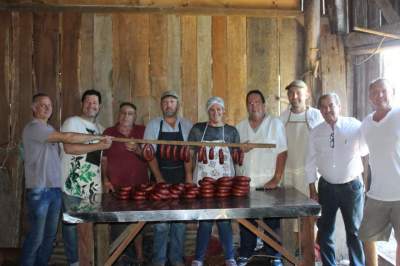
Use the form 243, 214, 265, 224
239, 218, 281, 258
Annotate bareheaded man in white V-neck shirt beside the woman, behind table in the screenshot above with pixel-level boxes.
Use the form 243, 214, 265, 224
236, 90, 287, 266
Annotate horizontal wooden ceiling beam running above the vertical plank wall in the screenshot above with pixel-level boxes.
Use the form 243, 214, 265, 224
0, 0, 302, 18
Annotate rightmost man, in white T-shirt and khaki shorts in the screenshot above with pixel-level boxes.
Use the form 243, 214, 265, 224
360, 79, 400, 266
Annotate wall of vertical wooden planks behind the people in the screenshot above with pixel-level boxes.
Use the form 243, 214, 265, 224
0, 12, 304, 247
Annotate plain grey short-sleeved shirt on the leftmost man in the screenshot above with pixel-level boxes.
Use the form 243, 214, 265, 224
22, 119, 61, 188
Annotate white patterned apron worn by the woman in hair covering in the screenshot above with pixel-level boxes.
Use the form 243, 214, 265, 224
193, 123, 235, 183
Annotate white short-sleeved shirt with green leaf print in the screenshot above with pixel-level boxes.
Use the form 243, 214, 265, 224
61, 116, 103, 198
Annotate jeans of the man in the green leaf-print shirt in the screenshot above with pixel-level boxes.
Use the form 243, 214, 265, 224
62, 193, 82, 265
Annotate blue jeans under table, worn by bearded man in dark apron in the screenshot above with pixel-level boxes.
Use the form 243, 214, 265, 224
152, 223, 186, 265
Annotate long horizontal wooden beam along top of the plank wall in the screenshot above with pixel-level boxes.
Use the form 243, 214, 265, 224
0, 3, 302, 18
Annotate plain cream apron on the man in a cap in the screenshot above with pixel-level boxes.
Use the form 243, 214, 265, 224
283, 108, 311, 195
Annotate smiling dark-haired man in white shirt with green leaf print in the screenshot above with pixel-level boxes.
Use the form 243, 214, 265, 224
61, 90, 111, 265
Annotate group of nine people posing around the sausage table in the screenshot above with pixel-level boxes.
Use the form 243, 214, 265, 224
21, 79, 400, 266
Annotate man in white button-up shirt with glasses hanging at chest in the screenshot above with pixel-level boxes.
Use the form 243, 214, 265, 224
306, 93, 368, 266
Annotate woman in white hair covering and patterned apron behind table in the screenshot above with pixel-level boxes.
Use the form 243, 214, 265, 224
189, 97, 240, 266
